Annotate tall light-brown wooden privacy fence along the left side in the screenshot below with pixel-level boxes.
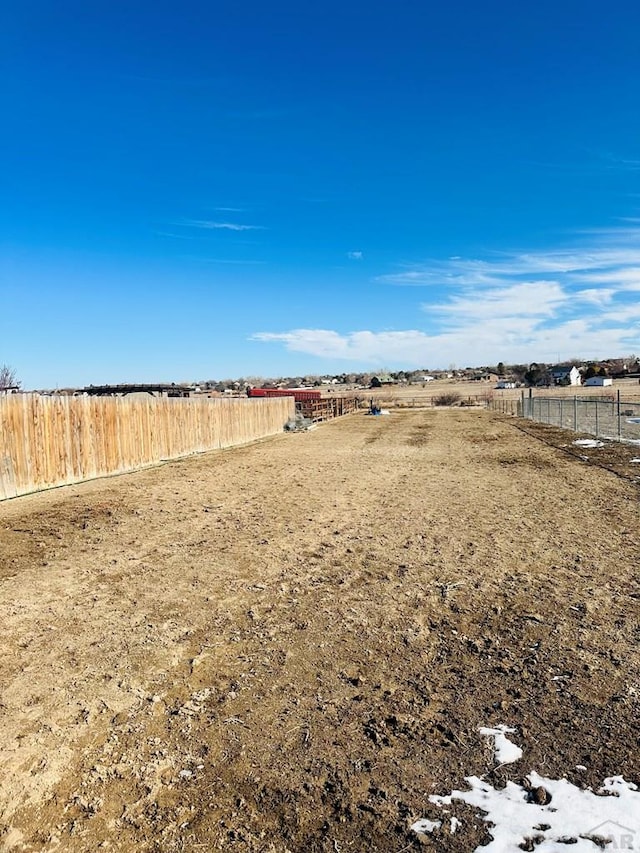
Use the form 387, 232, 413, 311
0, 394, 295, 500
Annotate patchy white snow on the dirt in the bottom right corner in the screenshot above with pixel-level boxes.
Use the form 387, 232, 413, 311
411, 726, 640, 853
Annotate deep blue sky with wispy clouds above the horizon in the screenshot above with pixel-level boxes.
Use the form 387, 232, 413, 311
0, 0, 640, 387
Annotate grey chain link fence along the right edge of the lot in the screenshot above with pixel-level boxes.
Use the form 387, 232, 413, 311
490, 392, 640, 443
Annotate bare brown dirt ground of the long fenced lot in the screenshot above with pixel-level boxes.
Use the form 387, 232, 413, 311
0, 409, 640, 853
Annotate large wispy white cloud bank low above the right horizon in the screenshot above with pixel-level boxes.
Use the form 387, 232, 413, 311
253, 227, 640, 367
